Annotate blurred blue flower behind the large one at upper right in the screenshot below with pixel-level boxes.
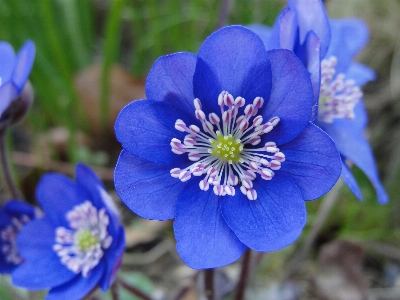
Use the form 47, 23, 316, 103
250, 0, 388, 204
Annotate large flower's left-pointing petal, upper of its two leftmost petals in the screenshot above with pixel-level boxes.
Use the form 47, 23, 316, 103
115, 100, 196, 164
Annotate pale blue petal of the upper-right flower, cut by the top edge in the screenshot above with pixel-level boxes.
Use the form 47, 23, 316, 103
289, 0, 331, 57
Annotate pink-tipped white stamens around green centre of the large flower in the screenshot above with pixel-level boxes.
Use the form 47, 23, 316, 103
170, 91, 285, 200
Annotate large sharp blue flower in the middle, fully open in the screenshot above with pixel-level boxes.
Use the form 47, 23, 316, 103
115, 26, 341, 269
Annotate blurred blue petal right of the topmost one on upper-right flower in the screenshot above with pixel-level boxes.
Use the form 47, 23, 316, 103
325, 19, 369, 74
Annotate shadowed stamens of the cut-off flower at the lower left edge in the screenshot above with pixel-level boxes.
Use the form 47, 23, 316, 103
0, 215, 31, 265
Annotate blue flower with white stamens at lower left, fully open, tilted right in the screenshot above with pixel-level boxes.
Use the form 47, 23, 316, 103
12, 164, 125, 299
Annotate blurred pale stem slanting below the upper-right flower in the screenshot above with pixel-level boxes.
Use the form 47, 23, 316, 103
283, 180, 343, 281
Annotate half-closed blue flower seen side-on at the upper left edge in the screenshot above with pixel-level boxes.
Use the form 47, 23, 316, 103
0, 41, 35, 126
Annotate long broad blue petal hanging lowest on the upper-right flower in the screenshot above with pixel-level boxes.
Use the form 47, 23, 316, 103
321, 120, 389, 204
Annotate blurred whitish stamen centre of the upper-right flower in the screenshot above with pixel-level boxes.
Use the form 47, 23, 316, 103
318, 56, 363, 123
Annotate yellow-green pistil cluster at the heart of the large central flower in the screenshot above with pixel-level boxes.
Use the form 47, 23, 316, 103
211, 132, 243, 164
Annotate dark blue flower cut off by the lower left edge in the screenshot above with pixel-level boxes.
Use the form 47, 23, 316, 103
0, 200, 36, 274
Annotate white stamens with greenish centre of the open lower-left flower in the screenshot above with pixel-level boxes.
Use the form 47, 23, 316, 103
53, 201, 112, 277
